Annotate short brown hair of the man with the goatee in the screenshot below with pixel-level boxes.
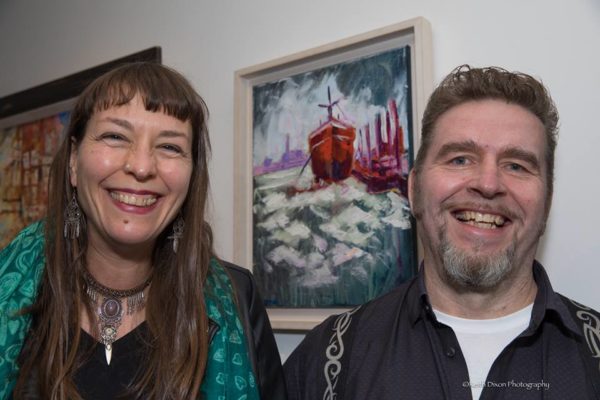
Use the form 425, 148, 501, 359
415, 65, 558, 205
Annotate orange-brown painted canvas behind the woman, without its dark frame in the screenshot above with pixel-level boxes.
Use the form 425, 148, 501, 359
0, 111, 70, 248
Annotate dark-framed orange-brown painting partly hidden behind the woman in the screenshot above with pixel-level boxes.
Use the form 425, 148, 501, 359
0, 47, 161, 249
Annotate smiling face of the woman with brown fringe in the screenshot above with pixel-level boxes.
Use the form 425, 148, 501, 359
70, 96, 193, 256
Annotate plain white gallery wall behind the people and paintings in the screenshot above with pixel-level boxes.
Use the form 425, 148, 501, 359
0, 0, 600, 360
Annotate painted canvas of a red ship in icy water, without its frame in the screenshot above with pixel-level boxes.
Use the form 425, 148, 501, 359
252, 46, 417, 308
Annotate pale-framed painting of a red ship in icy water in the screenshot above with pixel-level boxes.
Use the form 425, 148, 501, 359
234, 18, 432, 330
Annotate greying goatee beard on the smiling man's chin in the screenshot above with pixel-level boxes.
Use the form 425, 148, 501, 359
440, 233, 516, 292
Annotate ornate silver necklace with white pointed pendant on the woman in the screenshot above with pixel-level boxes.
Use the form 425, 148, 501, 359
83, 269, 152, 365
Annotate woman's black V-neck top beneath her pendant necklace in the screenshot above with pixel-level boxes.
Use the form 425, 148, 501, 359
75, 322, 148, 400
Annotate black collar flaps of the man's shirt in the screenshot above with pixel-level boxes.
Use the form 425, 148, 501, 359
407, 261, 581, 336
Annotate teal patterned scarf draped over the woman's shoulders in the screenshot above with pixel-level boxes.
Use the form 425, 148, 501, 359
0, 222, 259, 400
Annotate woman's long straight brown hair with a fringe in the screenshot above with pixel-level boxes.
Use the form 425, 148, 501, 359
14, 63, 214, 400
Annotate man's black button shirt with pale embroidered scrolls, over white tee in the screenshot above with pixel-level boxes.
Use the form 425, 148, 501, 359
284, 262, 600, 400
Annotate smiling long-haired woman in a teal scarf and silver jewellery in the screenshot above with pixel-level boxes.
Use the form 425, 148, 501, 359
0, 63, 285, 399
